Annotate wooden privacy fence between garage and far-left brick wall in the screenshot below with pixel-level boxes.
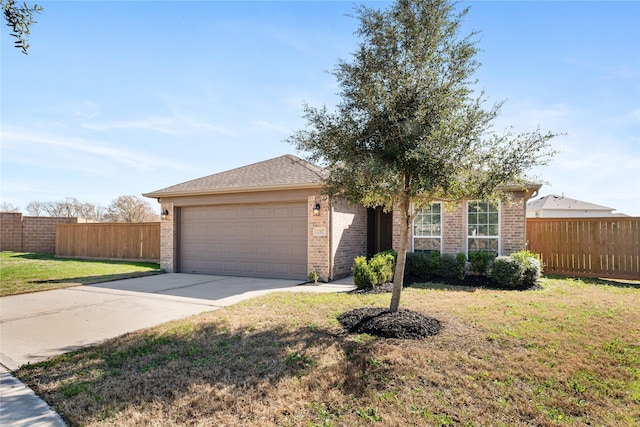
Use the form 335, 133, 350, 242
56, 222, 160, 262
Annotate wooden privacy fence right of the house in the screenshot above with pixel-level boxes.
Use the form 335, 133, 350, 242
527, 217, 640, 280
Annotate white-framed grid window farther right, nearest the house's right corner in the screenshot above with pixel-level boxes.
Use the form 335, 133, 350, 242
467, 201, 500, 255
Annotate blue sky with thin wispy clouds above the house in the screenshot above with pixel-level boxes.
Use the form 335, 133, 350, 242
0, 1, 640, 216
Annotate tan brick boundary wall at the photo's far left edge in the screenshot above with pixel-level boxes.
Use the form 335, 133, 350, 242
0, 212, 78, 253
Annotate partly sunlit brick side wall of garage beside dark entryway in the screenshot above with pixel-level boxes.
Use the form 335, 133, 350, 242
331, 201, 367, 279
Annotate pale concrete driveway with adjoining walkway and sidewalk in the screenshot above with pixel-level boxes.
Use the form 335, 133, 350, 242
0, 273, 354, 427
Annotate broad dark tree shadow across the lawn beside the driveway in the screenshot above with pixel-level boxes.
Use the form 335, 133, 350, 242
15, 321, 416, 425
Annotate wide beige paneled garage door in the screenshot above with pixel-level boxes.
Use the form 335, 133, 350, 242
179, 203, 307, 280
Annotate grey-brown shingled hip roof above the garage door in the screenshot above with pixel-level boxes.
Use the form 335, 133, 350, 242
143, 154, 325, 198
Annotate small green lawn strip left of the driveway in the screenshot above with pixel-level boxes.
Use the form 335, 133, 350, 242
0, 252, 161, 296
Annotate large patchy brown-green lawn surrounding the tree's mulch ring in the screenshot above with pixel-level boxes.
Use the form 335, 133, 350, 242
16, 278, 640, 426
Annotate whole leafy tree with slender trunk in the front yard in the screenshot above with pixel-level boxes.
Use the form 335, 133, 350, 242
289, 0, 555, 311
